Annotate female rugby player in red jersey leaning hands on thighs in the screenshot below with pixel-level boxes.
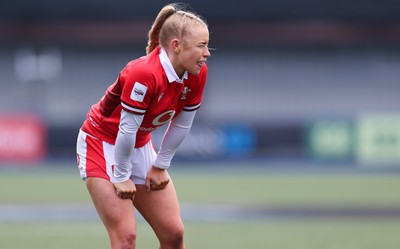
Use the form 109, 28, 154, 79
77, 4, 210, 249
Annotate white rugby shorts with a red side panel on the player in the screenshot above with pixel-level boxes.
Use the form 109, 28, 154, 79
76, 130, 157, 185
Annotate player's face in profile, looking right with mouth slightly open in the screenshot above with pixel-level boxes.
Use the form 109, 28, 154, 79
178, 24, 211, 75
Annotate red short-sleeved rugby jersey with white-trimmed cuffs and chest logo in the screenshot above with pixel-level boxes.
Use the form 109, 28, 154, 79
81, 47, 207, 148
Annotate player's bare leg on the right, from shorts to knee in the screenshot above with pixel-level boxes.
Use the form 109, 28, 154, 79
134, 181, 185, 249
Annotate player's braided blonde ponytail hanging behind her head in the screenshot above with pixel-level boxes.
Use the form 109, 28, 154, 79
146, 4, 177, 54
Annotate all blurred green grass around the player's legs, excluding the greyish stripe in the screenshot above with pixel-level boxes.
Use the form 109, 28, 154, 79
0, 162, 400, 249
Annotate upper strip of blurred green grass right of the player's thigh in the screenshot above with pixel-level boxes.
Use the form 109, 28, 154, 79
174, 169, 400, 207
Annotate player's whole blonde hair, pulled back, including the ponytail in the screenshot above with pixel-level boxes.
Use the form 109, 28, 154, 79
146, 3, 207, 54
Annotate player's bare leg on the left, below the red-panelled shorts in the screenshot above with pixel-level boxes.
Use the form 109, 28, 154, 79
86, 178, 136, 249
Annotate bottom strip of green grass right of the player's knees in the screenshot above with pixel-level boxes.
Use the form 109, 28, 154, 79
187, 220, 400, 249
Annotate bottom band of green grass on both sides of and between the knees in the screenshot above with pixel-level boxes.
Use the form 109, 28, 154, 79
0, 220, 400, 249
